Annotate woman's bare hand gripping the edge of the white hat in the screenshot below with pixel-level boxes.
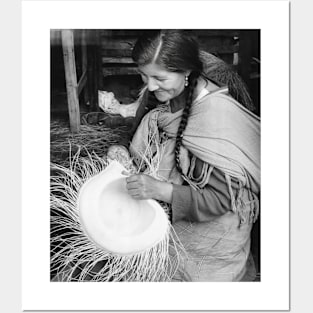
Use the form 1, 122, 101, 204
126, 174, 173, 203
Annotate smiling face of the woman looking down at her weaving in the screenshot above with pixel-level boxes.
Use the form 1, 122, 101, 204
138, 63, 189, 102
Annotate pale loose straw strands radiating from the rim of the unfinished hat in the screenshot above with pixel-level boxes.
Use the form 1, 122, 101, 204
50, 144, 184, 281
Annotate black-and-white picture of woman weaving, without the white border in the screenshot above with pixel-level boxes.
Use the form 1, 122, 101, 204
50, 29, 261, 282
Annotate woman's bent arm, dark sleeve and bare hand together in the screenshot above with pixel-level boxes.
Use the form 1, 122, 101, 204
126, 158, 239, 222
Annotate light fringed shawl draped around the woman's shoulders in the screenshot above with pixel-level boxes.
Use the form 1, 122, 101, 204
130, 88, 260, 223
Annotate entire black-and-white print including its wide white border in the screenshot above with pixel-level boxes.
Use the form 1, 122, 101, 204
22, 1, 289, 310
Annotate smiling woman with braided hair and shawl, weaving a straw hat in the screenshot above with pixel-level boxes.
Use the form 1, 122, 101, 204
126, 30, 260, 281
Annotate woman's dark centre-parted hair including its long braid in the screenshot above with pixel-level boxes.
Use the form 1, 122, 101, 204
132, 30, 203, 174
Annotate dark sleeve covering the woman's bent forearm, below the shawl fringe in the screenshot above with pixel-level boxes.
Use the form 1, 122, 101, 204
172, 163, 236, 222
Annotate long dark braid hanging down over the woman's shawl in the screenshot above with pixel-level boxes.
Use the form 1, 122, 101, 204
175, 74, 199, 175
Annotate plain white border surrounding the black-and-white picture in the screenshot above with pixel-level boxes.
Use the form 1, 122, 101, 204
22, 1, 289, 311
